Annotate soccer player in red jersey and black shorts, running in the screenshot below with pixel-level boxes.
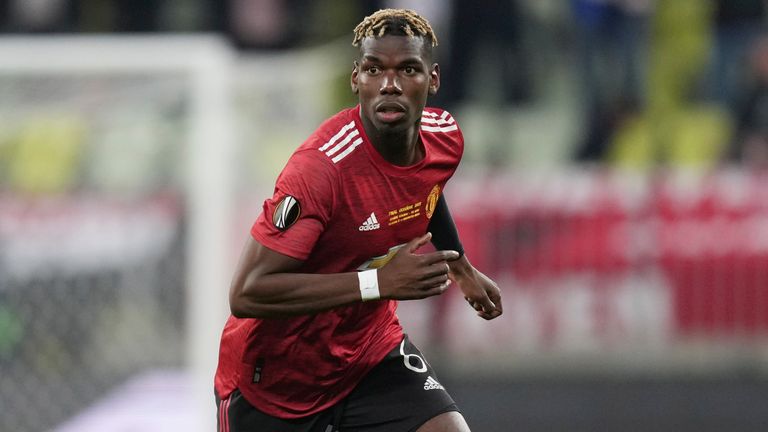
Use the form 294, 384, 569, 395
215, 9, 502, 432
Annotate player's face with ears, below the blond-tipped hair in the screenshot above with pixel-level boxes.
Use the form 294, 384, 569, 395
352, 35, 440, 132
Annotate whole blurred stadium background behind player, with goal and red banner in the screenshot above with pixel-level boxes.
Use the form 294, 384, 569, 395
0, 0, 768, 431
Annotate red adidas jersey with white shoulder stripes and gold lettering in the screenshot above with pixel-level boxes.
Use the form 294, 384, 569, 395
215, 107, 464, 418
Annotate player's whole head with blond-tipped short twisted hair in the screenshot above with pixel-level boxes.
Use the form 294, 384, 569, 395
351, 9, 440, 132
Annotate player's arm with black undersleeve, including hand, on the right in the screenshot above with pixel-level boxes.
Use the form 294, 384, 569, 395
427, 194, 503, 320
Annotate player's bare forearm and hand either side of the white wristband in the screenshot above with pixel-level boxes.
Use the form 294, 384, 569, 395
229, 233, 458, 318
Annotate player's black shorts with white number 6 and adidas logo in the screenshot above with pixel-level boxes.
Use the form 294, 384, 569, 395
216, 336, 458, 432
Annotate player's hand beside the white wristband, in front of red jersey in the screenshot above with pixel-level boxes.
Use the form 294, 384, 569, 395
378, 233, 459, 300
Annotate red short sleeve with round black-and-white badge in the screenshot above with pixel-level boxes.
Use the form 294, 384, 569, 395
251, 150, 337, 260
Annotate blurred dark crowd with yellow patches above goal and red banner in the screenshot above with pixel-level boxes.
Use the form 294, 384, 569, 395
0, 0, 768, 168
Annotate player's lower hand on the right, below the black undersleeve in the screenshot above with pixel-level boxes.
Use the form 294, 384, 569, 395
450, 256, 503, 320
